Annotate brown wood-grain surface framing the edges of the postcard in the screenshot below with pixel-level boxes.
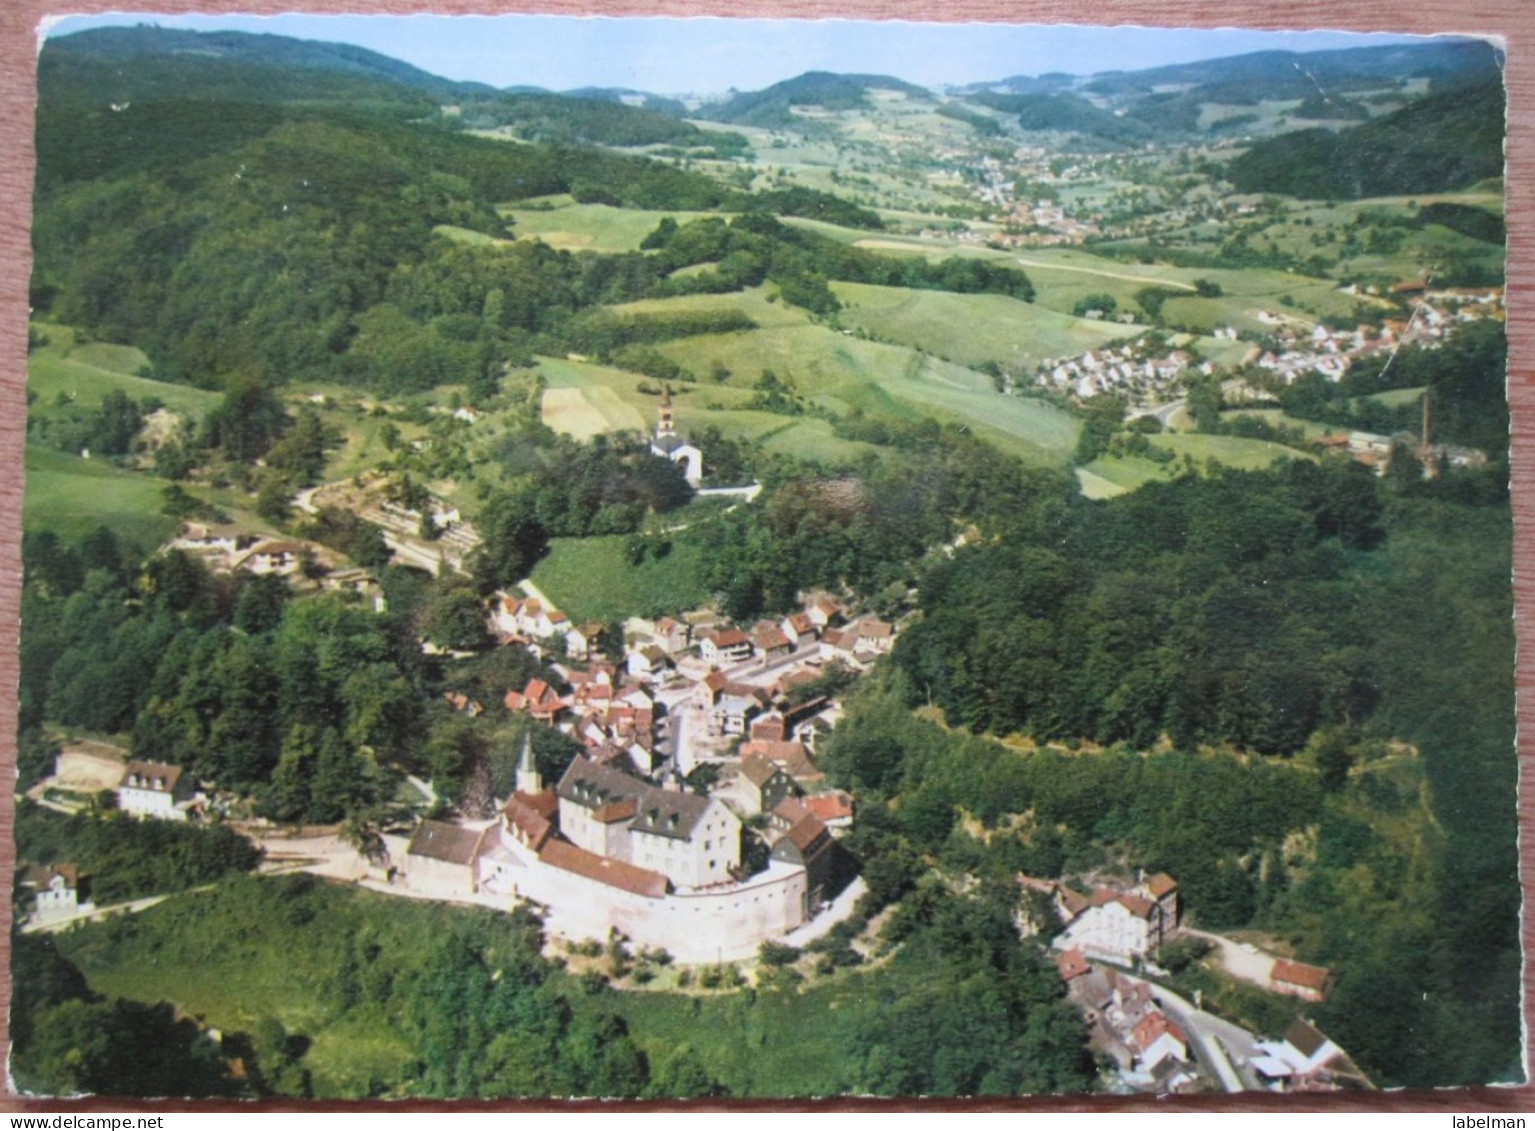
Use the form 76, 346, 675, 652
0, 0, 1535, 1114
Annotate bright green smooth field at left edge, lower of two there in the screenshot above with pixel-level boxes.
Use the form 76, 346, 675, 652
21, 443, 177, 551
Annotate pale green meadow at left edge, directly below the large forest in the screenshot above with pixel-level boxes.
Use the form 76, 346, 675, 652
26, 322, 220, 419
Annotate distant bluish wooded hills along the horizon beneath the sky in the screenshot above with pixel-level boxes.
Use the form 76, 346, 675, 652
38, 25, 1503, 178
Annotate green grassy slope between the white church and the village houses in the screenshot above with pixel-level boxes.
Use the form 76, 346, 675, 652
533, 534, 709, 623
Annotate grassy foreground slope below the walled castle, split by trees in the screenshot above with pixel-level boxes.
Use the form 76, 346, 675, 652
44, 879, 929, 1097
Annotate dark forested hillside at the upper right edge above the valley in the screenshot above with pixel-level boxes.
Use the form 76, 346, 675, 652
1226, 83, 1506, 199
